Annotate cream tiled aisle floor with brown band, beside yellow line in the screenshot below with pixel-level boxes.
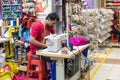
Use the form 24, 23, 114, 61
90, 48, 120, 80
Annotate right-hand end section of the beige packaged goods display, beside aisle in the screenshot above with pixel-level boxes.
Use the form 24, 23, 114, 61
98, 9, 114, 43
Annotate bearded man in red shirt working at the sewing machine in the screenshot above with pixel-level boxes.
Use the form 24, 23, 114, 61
29, 13, 59, 80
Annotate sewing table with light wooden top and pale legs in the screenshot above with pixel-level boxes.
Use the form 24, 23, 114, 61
36, 44, 90, 80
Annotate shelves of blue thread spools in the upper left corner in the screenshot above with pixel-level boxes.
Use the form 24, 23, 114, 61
2, 0, 22, 26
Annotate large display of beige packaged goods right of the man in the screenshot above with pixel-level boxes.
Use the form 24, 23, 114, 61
71, 9, 114, 48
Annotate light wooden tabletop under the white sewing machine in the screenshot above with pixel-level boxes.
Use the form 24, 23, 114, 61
36, 44, 90, 58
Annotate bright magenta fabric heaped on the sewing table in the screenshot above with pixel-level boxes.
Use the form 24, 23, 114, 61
69, 37, 89, 46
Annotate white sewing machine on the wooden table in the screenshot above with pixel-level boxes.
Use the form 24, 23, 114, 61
45, 33, 66, 52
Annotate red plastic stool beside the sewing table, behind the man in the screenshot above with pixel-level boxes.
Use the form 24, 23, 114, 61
27, 52, 47, 80
